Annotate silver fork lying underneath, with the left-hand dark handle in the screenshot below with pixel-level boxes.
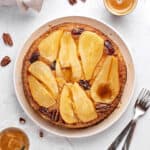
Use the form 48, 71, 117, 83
108, 88, 150, 150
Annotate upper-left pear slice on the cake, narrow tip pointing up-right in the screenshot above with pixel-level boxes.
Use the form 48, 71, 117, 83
38, 30, 63, 62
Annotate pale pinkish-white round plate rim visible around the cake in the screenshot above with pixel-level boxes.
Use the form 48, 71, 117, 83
14, 16, 135, 138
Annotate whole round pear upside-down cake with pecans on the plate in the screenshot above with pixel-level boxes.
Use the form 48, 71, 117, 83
22, 23, 127, 128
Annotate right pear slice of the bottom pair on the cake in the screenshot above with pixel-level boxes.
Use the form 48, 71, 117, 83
71, 83, 97, 122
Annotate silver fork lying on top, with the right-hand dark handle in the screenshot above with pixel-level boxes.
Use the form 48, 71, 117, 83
122, 91, 150, 150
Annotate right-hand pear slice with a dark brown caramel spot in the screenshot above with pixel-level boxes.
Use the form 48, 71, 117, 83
91, 56, 120, 103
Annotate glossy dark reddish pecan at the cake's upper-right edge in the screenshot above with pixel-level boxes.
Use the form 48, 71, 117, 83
104, 40, 115, 55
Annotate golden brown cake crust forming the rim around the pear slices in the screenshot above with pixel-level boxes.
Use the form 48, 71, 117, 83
22, 22, 127, 128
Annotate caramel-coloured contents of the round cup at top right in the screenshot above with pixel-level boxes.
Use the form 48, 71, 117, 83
105, 0, 137, 14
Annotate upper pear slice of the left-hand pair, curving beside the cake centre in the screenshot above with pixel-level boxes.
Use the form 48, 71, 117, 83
28, 61, 58, 98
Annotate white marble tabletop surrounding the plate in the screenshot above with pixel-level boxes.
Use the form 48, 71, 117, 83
0, 0, 150, 150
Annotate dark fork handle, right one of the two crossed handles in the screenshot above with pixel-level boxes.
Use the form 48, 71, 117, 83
122, 120, 137, 150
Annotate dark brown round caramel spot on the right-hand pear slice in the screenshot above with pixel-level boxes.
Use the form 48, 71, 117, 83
97, 84, 112, 99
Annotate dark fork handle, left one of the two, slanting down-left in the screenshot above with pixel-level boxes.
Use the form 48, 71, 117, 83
107, 120, 133, 150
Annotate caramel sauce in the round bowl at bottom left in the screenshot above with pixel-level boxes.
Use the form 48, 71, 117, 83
0, 128, 29, 150
